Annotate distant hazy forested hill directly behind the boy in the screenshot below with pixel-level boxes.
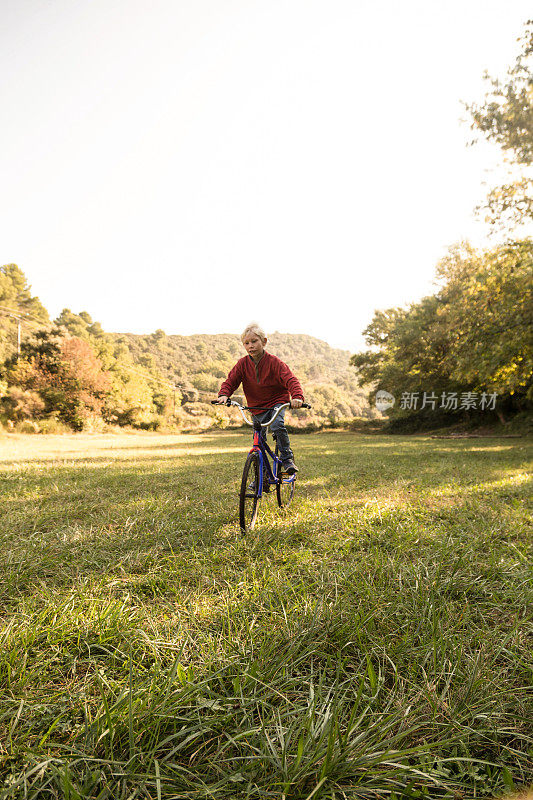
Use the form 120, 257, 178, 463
112, 330, 373, 420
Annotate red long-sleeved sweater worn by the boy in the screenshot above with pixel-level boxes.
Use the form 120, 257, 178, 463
218, 350, 304, 414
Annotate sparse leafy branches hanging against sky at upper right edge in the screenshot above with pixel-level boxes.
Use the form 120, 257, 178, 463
467, 20, 533, 230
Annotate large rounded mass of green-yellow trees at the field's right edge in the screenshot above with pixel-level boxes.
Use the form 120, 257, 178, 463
351, 240, 533, 412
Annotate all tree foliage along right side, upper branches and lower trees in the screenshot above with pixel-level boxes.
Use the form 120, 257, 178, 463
351, 21, 533, 432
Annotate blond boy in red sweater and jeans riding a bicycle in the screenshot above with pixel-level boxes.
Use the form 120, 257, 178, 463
218, 323, 304, 475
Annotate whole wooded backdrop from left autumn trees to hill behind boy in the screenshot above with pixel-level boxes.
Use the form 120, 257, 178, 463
0, 264, 370, 432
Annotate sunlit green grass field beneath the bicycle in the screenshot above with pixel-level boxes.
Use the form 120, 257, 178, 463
0, 431, 533, 800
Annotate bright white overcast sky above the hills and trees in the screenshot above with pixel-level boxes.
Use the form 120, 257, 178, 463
0, 0, 533, 351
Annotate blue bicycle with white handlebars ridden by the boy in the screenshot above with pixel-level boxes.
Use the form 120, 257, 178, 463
211, 399, 311, 533
